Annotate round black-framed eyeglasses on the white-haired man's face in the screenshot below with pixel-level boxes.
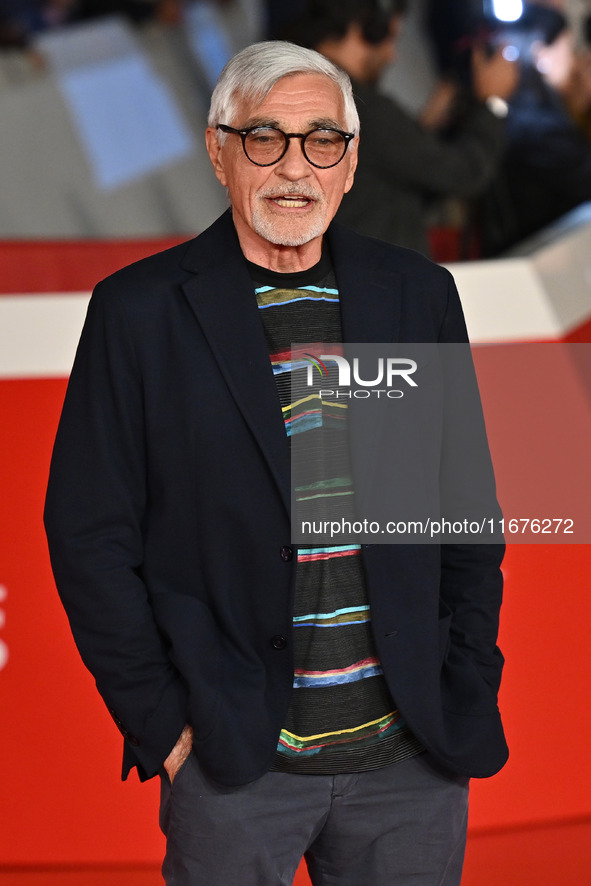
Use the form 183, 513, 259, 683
217, 123, 355, 169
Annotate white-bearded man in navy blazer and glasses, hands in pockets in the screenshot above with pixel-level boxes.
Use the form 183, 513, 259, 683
46, 42, 506, 886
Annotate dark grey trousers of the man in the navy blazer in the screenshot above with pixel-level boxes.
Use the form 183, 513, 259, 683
160, 754, 468, 886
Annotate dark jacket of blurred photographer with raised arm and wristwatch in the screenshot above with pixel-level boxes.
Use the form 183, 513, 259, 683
337, 82, 505, 255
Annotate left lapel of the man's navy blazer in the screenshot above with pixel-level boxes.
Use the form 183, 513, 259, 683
183, 213, 290, 512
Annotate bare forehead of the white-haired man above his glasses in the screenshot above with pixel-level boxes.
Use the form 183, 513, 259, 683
237, 74, 344, 126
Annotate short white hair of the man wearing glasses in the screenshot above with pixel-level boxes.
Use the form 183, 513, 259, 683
207, 40, 359, 145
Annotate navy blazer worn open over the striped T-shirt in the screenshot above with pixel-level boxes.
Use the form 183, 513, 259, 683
45, 213, 507, 785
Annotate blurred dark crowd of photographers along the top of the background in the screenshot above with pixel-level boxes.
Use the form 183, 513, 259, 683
0, 0, 591, 259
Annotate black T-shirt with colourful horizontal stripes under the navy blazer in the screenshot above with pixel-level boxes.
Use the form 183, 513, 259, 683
251, 256, 420, 773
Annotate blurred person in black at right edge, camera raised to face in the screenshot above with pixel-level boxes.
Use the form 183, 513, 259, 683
482, 3, 591, 255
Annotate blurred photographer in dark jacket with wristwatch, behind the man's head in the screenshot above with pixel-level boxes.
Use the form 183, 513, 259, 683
287, 0, 517, 255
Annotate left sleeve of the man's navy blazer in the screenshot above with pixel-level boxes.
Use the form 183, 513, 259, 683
45, 282, 187, 778
